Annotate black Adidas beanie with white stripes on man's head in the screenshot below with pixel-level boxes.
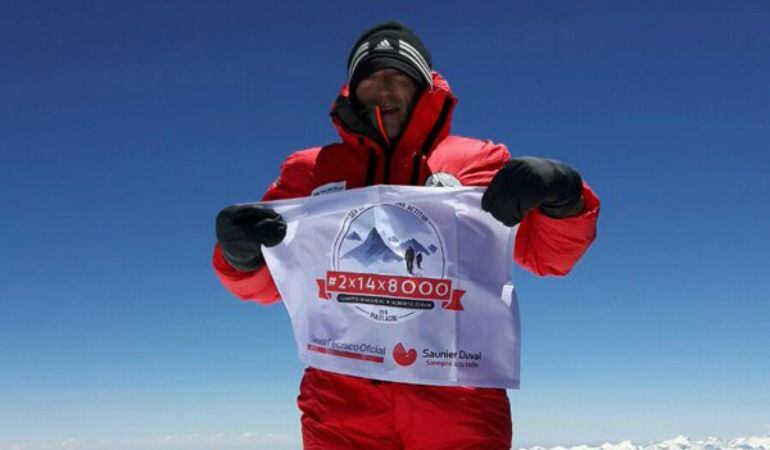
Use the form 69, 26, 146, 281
348, 21, 433, 100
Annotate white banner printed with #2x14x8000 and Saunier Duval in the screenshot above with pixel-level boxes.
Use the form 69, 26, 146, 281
262, 186, 520, 388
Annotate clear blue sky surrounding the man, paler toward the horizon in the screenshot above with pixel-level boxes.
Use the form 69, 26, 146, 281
0, 1, 770, 450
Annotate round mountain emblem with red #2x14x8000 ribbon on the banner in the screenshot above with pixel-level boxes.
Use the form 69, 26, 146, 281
318, 202, 465, 323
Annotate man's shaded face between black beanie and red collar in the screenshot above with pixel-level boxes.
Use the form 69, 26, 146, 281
355, 68, 417, 139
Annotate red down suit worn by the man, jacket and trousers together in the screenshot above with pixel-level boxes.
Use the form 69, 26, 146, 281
213, 72, 599, 449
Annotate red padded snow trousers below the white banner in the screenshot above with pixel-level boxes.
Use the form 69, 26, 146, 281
298, 368, 512, 450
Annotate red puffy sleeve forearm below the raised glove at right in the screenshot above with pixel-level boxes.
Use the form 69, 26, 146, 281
514, 183, 600, 275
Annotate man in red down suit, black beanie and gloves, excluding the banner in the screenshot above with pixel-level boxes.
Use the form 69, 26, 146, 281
214, 22, 599, 450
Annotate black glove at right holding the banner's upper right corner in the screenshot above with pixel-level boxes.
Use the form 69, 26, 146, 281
481, 157, 583, 227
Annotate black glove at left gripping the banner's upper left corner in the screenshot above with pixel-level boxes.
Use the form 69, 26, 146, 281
217, 205, 286, 271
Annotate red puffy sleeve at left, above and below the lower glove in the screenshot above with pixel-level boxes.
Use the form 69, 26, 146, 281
212, 148, 319, 305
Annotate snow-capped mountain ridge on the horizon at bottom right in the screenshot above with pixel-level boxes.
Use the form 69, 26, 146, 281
519, 436, 770, 450
